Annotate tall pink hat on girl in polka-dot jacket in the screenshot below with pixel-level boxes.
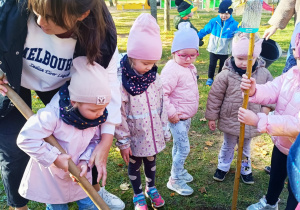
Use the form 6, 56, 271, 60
127, 13, 162, 60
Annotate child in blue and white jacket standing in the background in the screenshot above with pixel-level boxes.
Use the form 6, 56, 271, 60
198, 0, 238, 86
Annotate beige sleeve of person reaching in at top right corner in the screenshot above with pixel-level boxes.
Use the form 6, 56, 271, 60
268, 0, 300, 29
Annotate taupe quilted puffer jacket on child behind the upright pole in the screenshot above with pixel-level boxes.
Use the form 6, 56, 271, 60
205, 57, 275, 138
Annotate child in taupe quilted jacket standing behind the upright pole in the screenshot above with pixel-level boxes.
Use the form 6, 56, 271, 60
205, 33, 273, 184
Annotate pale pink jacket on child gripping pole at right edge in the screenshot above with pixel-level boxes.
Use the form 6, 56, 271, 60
249, 66, 300, 155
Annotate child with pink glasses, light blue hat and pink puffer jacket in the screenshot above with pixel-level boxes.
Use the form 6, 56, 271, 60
161, 23, 199, 195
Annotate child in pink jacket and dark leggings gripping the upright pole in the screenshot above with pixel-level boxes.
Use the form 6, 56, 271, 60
238, 31, 300, 210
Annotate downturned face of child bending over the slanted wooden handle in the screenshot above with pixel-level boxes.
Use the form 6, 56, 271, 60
71, 101, 108, 120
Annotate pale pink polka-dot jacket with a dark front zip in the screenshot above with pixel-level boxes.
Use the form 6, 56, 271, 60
115, 68, 171, 157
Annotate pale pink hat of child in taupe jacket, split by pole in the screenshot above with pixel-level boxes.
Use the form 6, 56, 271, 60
232, 36, 263, 58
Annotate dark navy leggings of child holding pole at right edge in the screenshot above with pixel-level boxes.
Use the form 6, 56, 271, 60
266, 146, 298, 210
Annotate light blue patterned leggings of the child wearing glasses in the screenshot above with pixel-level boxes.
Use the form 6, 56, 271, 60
170, 118, 191, 180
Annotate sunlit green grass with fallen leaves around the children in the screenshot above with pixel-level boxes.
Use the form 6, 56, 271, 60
0, 8, 293, 210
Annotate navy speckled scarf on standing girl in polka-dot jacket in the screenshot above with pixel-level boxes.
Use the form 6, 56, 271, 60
120, 55, 157, 96
